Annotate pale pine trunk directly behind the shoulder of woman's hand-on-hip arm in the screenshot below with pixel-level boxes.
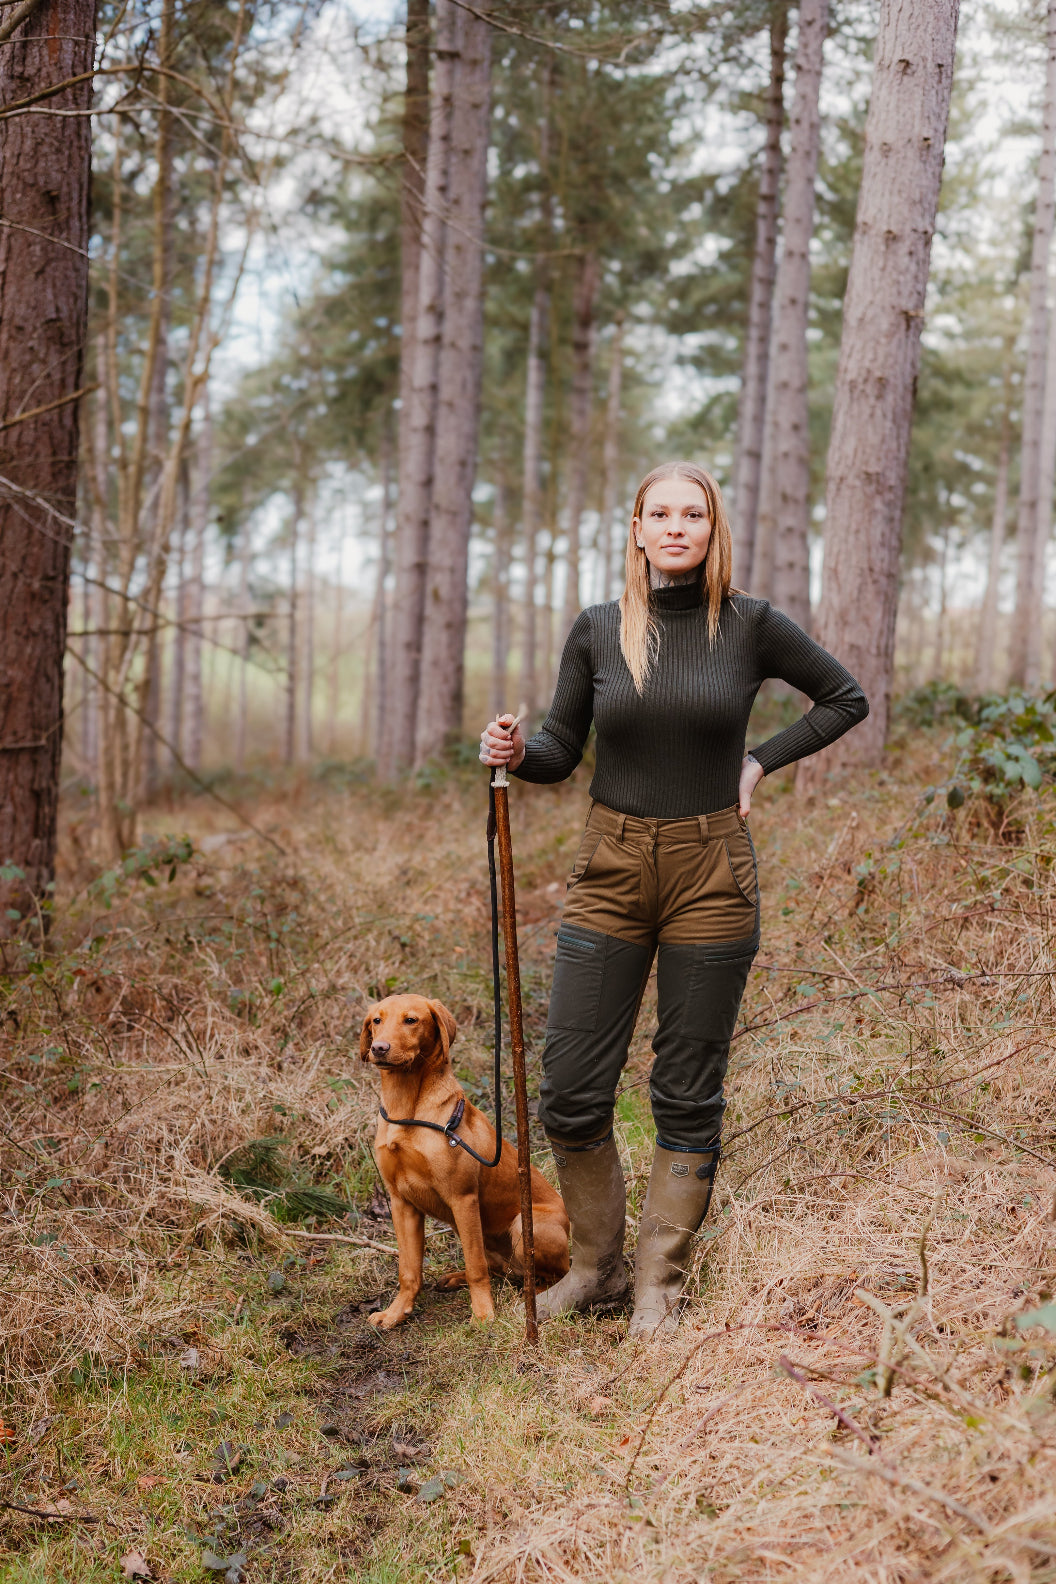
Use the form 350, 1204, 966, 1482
774, 0, 828, 627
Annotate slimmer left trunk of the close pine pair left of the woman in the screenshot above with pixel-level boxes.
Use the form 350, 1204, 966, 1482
380, 0, 462, 778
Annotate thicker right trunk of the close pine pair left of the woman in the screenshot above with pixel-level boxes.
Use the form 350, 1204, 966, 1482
415, 0, 491, 765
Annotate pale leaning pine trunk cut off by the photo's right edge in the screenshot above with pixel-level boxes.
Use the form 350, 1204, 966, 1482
1010, 0, 1056, 687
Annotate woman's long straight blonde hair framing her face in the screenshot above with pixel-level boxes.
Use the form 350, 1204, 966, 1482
619, 463, 733, 694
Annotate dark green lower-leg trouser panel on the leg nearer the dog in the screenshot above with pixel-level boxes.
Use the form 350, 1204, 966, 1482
538, 925, 652, 1140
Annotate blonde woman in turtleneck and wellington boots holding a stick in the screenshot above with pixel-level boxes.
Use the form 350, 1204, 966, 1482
480, 463, 869, 1335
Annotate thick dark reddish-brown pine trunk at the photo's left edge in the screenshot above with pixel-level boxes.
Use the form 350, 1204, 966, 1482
0, 0, 95, 935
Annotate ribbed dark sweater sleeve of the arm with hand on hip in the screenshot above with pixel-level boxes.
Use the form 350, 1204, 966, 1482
752, 600, 869, 775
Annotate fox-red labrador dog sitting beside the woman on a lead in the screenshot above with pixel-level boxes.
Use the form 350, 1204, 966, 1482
367, 995, 568, 1331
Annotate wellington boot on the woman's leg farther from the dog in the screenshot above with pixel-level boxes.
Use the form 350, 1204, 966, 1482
627, 1144, 719, 1337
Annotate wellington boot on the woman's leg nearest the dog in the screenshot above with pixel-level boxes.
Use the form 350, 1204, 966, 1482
535, 1133, 627, 1319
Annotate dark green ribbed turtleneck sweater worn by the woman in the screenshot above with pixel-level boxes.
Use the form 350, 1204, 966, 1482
515, 583, 869, 819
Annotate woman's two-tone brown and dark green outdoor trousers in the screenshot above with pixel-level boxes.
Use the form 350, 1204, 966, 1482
538, 803, 758, 1152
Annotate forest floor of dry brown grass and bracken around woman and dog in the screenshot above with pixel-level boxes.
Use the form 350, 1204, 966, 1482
0, 732, 1056, 1584
